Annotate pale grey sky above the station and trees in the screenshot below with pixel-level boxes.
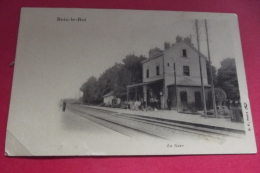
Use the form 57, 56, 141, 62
15, 9, 234, 97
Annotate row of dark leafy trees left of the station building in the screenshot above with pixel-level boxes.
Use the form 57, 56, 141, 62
80, 54, 146, 104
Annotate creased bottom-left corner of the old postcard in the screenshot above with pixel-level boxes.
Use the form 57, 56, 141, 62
4, 130, 33, 156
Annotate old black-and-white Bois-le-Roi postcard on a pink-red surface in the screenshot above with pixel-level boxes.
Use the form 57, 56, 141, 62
5, 8, 257, 156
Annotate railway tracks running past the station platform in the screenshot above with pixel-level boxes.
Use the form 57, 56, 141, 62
68, 105, 245, 140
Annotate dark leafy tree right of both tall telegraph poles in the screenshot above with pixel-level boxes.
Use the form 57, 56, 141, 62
217, 58, 240, 100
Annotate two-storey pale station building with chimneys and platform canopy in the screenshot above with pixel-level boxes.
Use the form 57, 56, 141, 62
127, 36, 211, 111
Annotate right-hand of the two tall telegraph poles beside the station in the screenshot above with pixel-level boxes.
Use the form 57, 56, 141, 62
205, 19, 218, 117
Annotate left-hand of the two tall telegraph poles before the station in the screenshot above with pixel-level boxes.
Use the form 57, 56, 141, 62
195, 19, 207, 118
